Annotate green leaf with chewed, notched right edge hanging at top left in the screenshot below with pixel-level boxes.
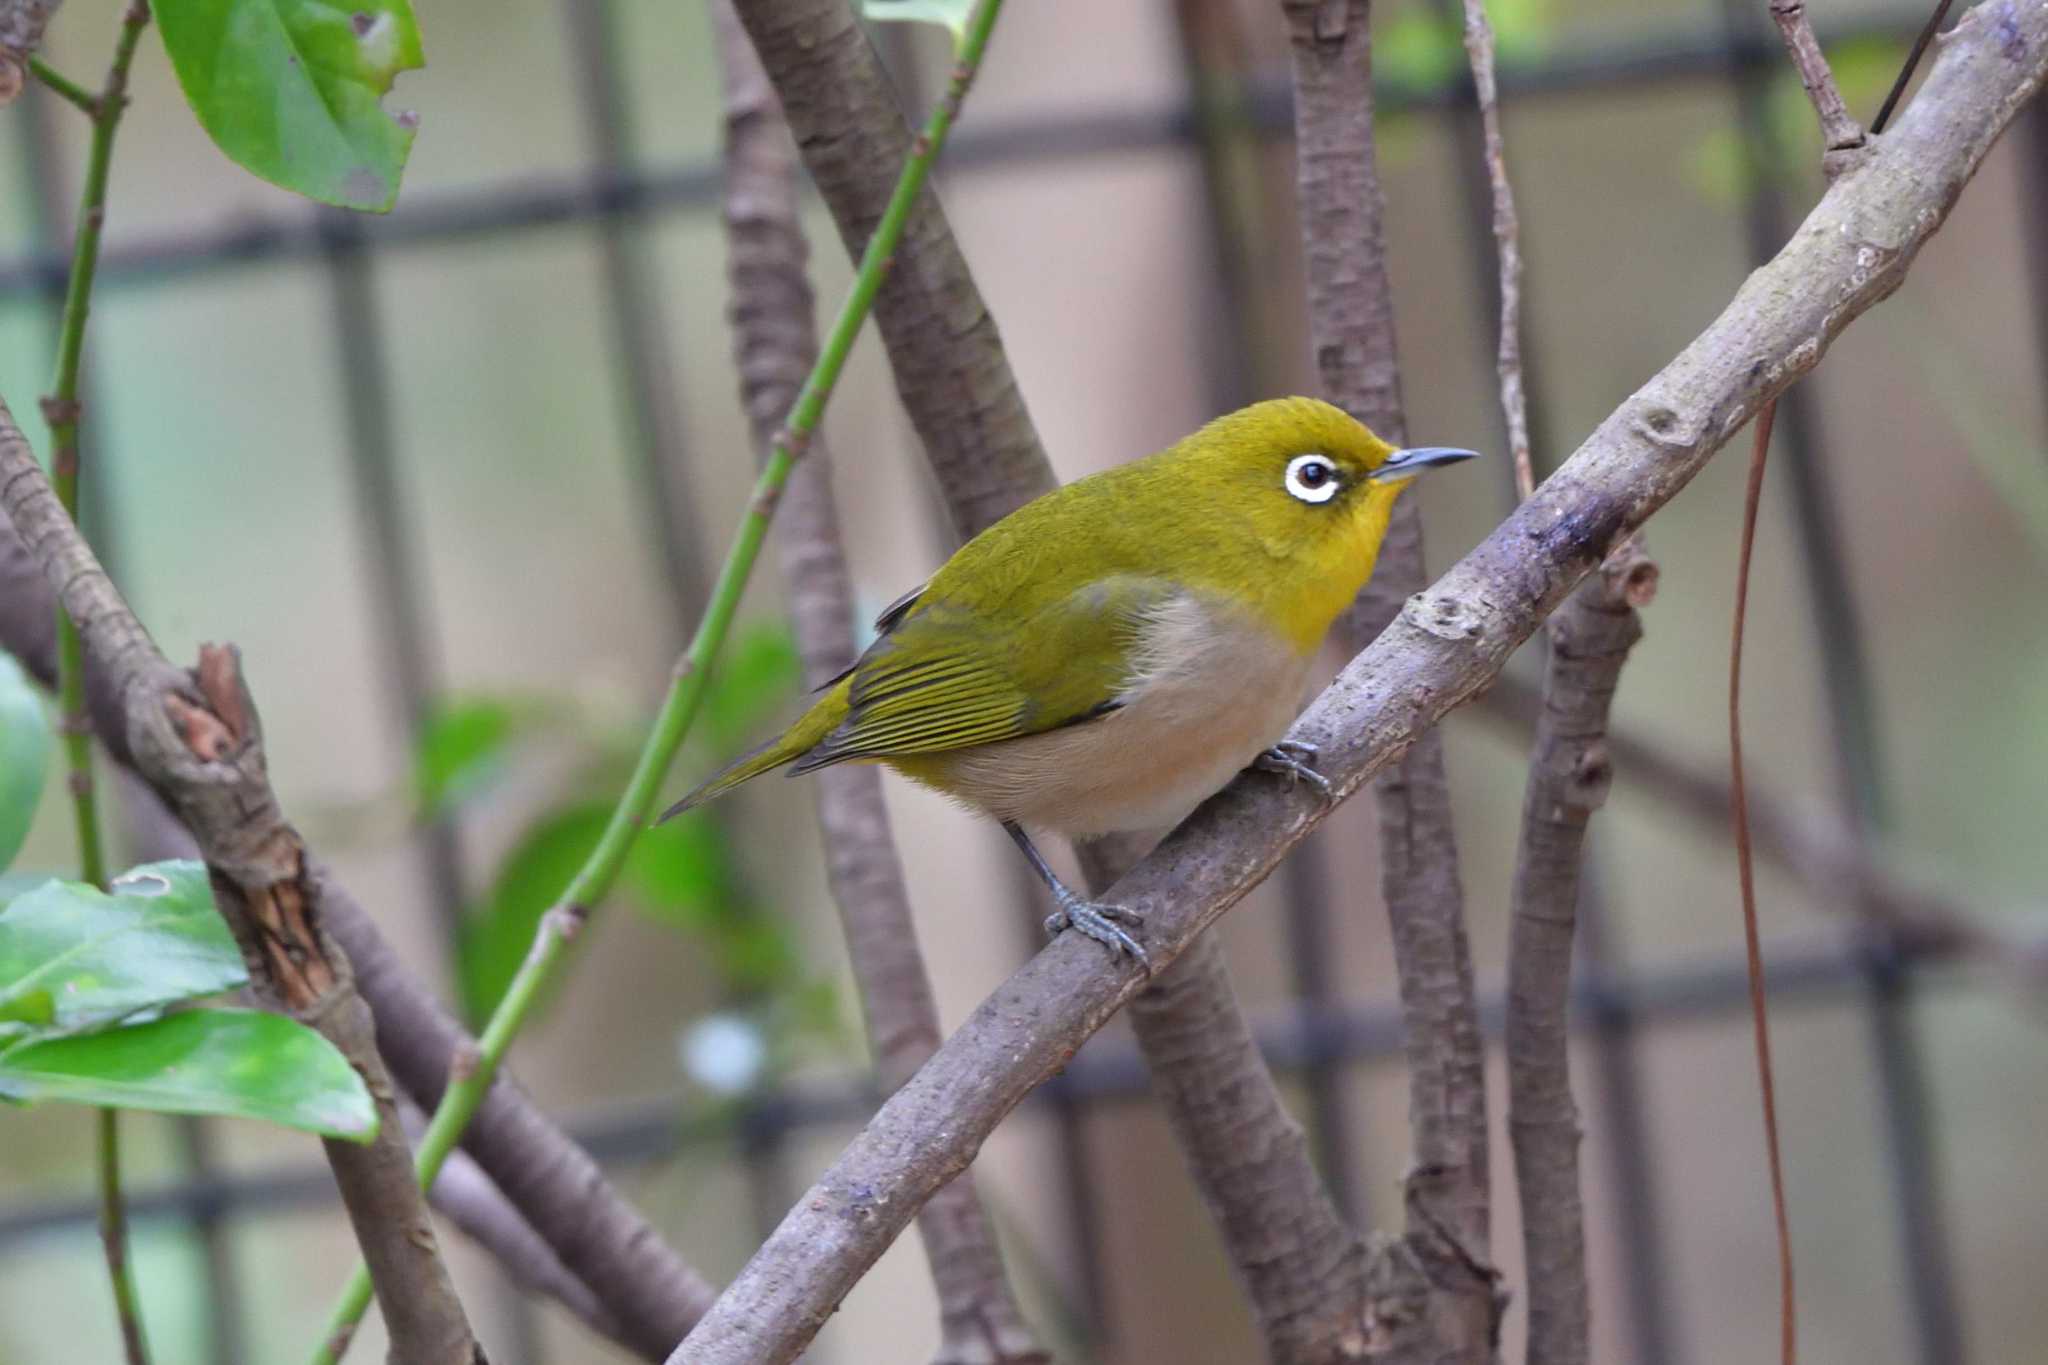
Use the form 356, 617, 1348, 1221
156, 0, 426, 213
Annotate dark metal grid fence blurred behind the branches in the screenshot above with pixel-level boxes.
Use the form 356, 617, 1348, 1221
0, 0, 1998, 1365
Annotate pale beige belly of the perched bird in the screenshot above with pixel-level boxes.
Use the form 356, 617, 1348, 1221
891, 609, 1309, 835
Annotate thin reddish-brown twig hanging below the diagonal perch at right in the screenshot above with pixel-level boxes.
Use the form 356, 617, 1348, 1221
1729, 399, 1798, 1365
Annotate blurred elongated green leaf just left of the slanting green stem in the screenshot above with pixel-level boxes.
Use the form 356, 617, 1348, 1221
457, 802, 610, 1023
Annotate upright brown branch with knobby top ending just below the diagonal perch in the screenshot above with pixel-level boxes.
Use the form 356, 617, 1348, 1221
1507, 536, 1657, 1365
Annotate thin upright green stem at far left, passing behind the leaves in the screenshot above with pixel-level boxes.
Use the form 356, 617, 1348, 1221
45, 10, 150, 1365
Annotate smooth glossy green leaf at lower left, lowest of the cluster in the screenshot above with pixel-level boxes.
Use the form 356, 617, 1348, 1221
0, 1009, 377, 1142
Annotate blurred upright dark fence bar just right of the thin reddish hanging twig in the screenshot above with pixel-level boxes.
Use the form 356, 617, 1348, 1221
1722, 0, 1968, 1365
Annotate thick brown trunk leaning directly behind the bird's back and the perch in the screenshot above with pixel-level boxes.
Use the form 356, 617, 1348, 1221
735, 0, 1376, 1361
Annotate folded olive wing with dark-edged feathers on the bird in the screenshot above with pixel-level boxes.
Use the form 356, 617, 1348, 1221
795, 577, 1176, 772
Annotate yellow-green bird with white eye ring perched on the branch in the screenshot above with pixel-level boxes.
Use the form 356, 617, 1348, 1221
662, 397, 1473, 958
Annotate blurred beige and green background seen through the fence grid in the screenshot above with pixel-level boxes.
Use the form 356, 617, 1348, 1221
0, 0, 2048, 1365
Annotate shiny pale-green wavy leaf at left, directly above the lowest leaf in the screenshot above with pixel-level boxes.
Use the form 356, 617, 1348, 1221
0, 862, 248, 1033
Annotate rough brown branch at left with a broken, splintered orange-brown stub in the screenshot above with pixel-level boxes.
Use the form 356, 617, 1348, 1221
0, 403, 481, 1365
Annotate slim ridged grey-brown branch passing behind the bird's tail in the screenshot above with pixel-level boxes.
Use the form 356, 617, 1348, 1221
711, 0, 1051, 1365
